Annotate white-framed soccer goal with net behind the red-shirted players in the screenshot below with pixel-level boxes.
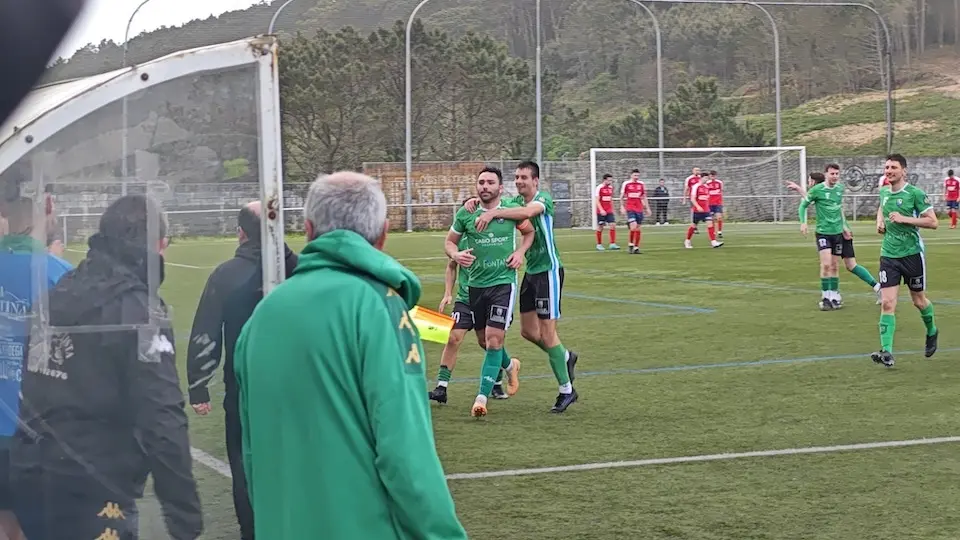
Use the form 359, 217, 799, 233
590, 146, 807, 227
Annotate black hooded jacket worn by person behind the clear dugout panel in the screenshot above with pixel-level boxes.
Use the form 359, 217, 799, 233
12, 235, 203, 540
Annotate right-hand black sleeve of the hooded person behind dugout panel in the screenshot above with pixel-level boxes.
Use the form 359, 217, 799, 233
121, 296, 203, 540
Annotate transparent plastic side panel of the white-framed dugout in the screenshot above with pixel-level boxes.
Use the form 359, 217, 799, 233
0, 45, 270, 540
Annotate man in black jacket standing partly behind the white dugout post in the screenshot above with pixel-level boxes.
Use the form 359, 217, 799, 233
187, 201, 297, 540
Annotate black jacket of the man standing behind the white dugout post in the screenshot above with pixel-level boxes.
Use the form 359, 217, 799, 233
187, 241, 297, 406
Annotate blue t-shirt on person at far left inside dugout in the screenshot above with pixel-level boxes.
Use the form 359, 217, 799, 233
0, 236, 72, 437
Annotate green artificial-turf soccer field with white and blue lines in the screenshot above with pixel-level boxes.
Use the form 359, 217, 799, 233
72, 224, 960, 540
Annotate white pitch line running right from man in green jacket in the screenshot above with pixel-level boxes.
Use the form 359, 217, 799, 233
447, 437, 960, 480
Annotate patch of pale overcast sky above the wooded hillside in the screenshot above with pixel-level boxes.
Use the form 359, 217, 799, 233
54, 0, 259, 58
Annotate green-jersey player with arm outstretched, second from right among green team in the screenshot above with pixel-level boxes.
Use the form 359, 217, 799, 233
787, 163, 880, 311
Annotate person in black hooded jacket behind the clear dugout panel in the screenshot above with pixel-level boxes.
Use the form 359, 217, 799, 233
11, 195, 203, 540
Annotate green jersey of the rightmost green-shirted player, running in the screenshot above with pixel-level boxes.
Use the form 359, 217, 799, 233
880, 184, 933, 259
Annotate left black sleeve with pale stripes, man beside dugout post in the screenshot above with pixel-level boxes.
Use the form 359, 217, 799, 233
187, 266, 225, 408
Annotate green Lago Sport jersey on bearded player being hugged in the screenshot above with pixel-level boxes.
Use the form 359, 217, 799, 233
450, 200, 517, 289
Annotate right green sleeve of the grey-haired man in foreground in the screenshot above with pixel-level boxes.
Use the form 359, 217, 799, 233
357, 293, 467, 540
